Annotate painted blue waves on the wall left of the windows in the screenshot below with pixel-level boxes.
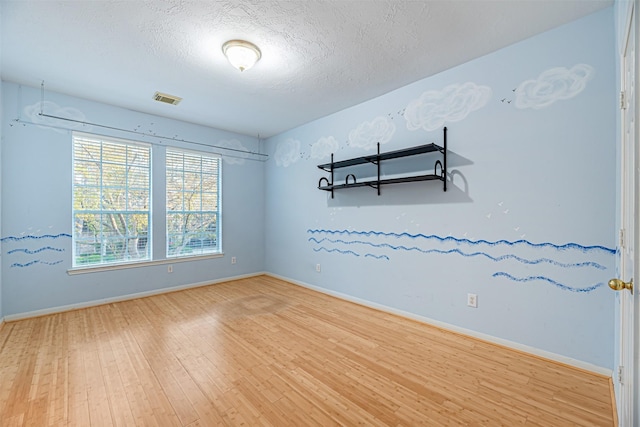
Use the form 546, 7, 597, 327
0, 233, 71, 268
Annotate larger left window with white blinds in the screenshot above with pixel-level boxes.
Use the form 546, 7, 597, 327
73, 133, 151, 267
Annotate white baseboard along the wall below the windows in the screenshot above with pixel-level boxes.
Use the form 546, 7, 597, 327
0, 272, 266, 324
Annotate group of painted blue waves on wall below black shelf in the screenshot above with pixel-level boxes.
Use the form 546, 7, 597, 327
307, 229, 616, 293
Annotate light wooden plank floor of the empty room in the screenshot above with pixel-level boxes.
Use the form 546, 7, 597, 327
0, 276, 614, 427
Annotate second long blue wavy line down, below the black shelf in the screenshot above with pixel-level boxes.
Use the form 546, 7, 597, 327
308, 237, 607, 270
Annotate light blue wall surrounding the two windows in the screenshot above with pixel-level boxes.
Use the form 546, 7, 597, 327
2, 82, 264, 316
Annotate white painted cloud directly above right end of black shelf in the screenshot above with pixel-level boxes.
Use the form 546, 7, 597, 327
404, 82, 492, 131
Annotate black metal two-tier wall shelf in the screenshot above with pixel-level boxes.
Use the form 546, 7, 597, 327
318, 127, 447, 198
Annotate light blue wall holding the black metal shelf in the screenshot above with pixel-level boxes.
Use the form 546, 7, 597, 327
266, 9, 616, 368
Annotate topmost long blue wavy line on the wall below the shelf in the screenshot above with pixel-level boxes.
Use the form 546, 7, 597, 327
307, 229, 616, 255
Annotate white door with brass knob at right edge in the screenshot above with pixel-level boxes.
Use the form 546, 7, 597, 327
610, 3, 640, 427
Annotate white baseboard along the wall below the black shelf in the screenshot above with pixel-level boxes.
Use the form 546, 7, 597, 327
265, 273, 613, 378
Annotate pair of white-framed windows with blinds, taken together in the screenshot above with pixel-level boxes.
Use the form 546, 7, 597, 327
73, 133, 221, 267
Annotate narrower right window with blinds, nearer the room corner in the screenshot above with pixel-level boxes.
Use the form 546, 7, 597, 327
166, 148, 220, 257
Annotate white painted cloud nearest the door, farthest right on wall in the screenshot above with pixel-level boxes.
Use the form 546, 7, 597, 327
515, 64, 594, 110
